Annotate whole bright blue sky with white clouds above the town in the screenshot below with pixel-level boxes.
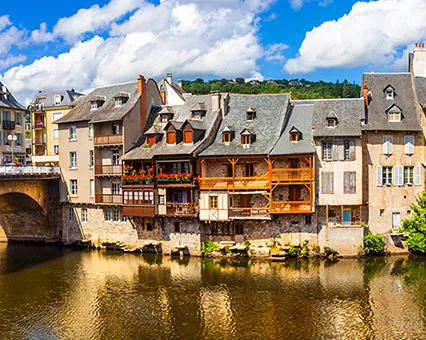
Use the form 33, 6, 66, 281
0, 0, 426, 104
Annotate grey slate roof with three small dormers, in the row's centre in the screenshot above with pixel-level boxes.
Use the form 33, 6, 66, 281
200, 94, 290, 157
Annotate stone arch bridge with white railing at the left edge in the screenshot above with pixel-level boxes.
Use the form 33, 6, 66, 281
0, 166, 62, 242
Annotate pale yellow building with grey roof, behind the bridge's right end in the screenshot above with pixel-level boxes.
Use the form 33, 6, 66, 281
30, 90, 83, 164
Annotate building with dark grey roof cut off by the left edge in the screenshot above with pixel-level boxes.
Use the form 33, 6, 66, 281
0, 82, 25, 164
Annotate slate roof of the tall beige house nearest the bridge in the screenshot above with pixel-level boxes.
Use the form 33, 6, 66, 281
55, 82, 139, 124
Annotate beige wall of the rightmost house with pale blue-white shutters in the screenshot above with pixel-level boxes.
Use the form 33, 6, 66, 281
363, 131, 424, 233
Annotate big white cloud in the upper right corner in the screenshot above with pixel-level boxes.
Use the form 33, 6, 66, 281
284, 0, 426, 74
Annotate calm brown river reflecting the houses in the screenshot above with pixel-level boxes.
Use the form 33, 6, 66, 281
0, 244, 426, 340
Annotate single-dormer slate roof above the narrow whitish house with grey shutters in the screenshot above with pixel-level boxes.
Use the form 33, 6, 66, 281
293, 98, 365, 137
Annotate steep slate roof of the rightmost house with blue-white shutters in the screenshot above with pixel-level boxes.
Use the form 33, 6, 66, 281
363, 73, 422, 131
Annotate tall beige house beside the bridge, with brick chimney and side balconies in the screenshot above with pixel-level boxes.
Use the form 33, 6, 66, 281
57, 76, 161, 244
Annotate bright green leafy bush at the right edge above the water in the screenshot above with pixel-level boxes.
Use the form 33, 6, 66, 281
402, 192, 426, 253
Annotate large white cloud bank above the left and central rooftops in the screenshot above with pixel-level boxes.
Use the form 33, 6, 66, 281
4, 0, 276, 98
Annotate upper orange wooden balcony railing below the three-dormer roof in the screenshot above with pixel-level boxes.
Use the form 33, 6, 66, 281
199, 175, 269, 190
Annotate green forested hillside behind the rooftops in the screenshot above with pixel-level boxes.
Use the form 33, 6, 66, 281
182, 78, 361, 99
